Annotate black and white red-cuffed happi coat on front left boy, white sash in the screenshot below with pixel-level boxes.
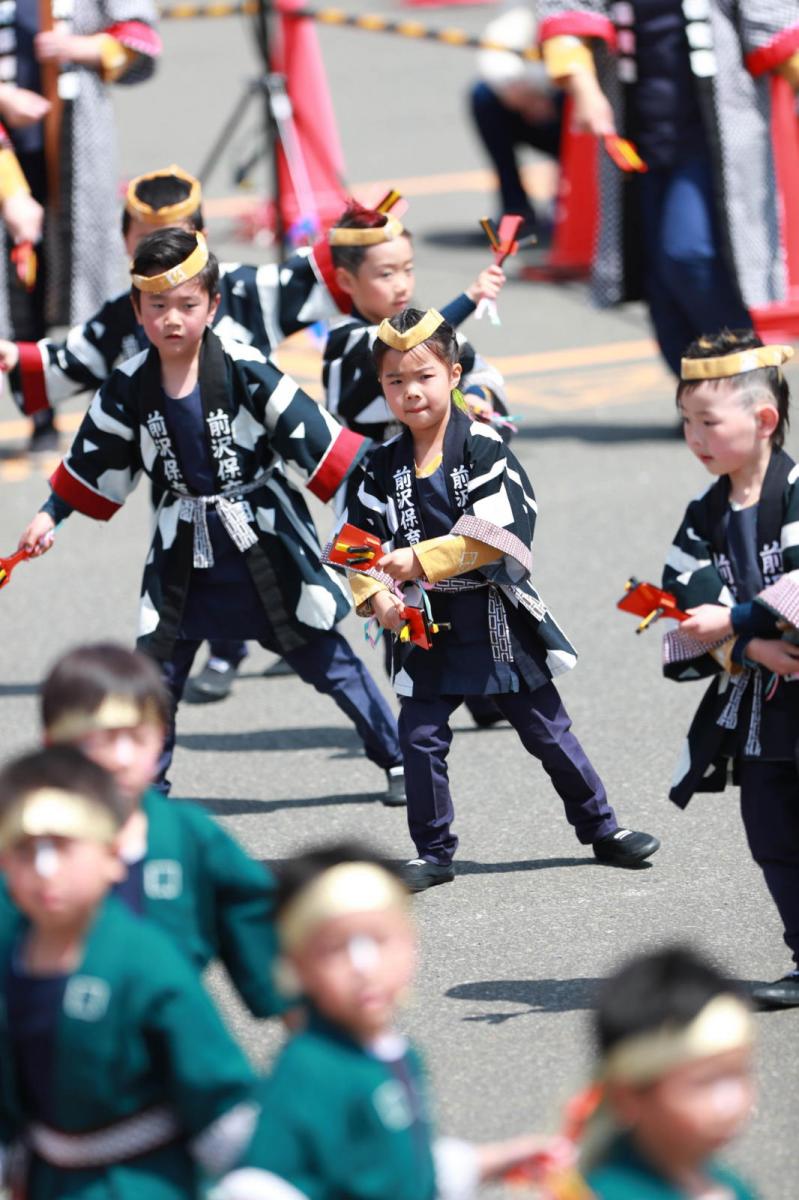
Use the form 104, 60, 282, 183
50, 330, 367, 660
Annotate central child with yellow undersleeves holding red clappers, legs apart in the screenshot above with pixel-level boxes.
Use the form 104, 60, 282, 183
338, 308, 660, 890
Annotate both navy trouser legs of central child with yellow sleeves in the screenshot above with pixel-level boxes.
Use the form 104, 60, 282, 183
400, 683, 619, 864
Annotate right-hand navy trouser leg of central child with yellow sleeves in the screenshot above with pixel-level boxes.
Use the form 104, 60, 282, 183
495, 683, 619, 845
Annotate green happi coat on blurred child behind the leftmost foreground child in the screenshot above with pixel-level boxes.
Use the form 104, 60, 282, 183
142, 790, 286, 1016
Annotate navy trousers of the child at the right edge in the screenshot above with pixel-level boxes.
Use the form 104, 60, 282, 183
738, 758, 799, 966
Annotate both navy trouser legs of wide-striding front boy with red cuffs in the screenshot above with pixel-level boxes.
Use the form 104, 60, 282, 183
155, 629, 402, 793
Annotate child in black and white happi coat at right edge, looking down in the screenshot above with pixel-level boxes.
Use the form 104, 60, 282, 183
663, 330, 799, 1006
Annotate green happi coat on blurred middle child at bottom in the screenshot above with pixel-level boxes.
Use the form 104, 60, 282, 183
214, 1013, 469, 1200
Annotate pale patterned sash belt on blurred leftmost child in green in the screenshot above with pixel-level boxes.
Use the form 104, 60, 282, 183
28, 1108, 181, 1171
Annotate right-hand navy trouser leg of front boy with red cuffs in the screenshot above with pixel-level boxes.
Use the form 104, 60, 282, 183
284, 630, 402, 770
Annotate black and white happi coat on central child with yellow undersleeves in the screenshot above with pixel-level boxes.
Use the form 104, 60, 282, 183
346, 406, 577, 697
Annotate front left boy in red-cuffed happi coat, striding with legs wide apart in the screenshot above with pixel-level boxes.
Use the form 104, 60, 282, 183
23, 229, 404, 804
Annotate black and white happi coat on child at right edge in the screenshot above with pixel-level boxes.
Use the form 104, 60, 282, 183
663, 450, 799, 808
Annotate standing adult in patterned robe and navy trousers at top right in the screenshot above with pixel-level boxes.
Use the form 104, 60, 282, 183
539, 0, 799, 378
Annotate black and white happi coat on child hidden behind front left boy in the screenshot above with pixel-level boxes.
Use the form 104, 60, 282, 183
10, 250, 341, 415
